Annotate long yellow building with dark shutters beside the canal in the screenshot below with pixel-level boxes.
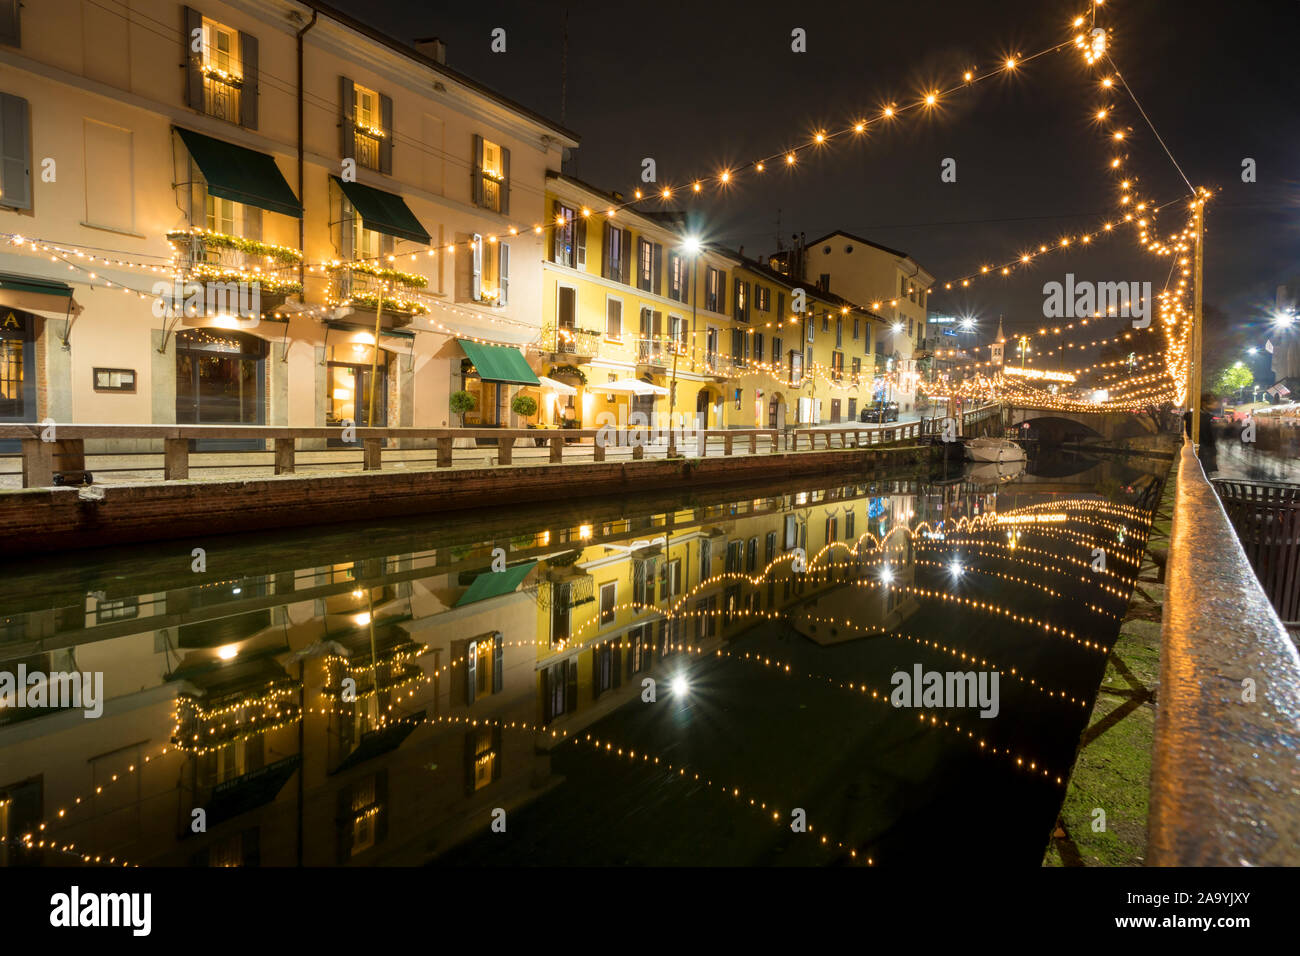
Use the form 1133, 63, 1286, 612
537, 172, 885, 429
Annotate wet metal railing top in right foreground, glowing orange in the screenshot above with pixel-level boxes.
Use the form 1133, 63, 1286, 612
1147, 444, 1300, 866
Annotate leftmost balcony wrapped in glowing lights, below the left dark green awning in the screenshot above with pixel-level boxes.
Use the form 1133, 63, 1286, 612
166, 229, 303, 310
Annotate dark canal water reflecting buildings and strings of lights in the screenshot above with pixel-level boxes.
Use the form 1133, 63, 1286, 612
0, 455, 1165, 866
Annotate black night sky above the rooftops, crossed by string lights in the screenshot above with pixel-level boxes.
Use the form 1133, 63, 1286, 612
334, 0, 1300, 374
